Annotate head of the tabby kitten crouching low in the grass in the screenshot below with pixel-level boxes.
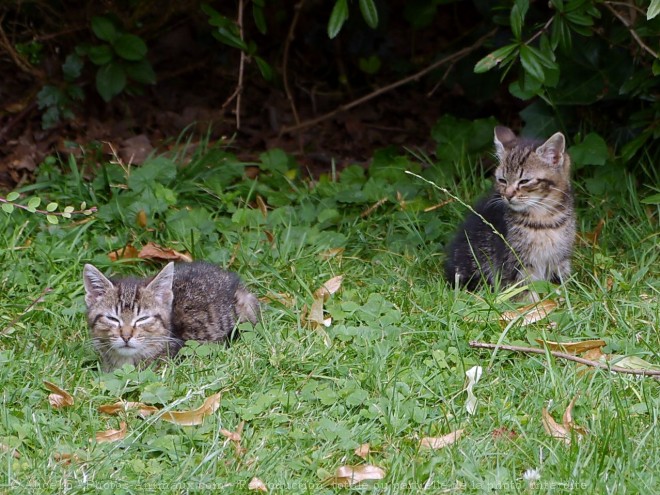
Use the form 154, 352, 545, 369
83, 263, 174, 370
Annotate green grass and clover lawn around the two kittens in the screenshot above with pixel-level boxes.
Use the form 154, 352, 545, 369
0, 140, 660, 494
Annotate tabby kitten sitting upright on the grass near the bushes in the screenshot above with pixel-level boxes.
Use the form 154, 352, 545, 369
445, 127, 575, 289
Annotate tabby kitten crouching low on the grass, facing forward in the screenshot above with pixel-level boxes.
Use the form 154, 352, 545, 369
83, 261, 259, 371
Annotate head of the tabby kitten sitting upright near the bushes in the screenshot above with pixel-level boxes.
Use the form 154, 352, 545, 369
495, 126, 571, 214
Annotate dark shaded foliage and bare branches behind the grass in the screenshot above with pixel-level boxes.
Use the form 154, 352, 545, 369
0, 0, 660, 190
